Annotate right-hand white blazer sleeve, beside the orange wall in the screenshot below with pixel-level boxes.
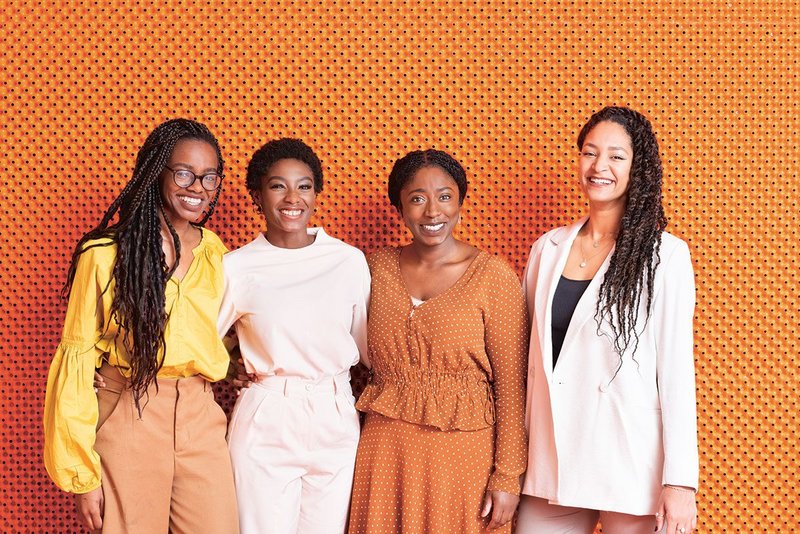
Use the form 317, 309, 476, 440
650, 241, 699, 489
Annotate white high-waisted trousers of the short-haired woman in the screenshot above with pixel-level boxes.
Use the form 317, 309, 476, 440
228, 373, 359, 534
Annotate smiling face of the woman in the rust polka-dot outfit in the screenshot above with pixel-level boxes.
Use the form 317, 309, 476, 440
400, 167, 461, 246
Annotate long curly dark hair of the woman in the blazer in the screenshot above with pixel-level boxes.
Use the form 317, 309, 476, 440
578, 107, 667, 365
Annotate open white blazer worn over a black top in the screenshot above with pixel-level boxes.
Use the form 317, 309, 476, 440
522, 218, 698, 515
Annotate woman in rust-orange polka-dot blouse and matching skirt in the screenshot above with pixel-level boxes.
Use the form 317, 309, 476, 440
350, 150, 527, 534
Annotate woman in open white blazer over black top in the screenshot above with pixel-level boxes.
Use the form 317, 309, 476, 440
518, 107, 698, 534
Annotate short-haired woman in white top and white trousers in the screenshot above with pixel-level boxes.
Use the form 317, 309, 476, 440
218, 139, 370, 534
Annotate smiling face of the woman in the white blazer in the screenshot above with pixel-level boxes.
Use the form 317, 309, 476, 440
578, 121, 633, 209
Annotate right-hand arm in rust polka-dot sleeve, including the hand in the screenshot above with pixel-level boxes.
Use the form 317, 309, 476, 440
483, 262, 528, 528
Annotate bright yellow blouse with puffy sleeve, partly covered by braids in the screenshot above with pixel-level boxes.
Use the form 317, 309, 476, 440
44, 229, 229, 493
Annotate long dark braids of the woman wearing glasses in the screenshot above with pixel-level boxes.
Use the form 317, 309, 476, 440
61, 119, 223, 414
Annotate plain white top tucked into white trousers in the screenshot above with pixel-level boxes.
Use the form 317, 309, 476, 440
217, 228, 370, 380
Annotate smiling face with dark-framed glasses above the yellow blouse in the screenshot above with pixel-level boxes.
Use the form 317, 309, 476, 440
159, 139, 219, 226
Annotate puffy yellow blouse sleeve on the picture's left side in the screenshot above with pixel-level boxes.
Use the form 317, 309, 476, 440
43, 246, 113, 493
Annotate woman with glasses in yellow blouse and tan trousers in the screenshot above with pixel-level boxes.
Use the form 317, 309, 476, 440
44, 119, 238, 533
